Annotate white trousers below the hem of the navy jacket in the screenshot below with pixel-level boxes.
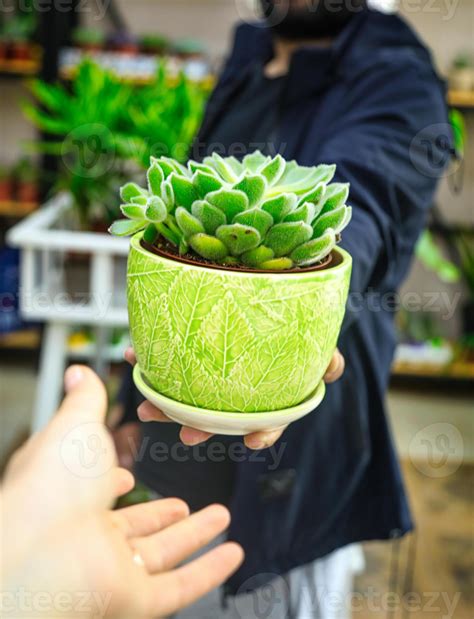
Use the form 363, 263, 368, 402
176, 545, 364, 619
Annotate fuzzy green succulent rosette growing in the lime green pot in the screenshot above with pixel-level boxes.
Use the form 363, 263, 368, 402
110, 151, 352, 271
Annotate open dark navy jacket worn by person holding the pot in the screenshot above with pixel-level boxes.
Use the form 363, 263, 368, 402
194, 11, 451, 592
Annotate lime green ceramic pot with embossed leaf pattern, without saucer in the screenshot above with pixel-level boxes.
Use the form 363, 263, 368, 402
128, 233, 352, 413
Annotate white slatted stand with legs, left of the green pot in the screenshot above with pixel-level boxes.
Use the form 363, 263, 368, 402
7, 194, 129, 431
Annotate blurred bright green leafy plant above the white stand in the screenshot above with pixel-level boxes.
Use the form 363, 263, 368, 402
22, 60, 208, 228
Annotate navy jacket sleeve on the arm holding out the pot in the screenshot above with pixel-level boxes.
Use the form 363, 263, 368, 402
320, 63, 451, 328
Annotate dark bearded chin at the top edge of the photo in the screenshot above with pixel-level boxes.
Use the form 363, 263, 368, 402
260, 0, 366, 40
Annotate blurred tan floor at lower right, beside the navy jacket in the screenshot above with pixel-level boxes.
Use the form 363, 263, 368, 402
352, 462, 474, 619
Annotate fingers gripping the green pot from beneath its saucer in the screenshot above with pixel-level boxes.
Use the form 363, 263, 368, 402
125, 348, 345, 449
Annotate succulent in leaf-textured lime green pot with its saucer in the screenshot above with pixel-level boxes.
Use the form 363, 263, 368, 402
111, 151, 351, 434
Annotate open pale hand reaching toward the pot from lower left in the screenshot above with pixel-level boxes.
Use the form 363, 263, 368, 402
0, 366, 243, 619
